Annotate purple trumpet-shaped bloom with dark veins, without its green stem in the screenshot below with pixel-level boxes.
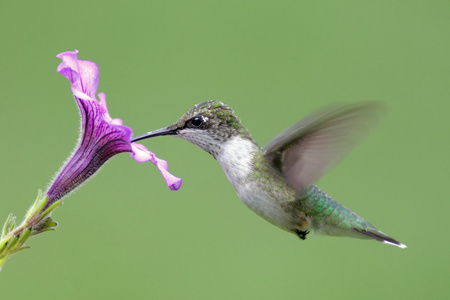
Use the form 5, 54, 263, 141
46, 50, 182, 208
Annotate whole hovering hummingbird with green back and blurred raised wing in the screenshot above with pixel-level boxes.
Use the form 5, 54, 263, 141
132, 100, 406, 248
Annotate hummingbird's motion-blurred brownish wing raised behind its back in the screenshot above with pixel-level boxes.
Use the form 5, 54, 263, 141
265, 102, 385, 191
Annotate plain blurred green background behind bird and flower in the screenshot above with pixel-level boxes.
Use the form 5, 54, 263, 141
0, 0, 450, 299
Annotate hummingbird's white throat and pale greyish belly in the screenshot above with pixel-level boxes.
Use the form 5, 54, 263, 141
216, 136, 309, 232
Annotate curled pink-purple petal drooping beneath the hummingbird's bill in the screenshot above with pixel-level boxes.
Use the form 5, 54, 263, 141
130, 143, 183, 191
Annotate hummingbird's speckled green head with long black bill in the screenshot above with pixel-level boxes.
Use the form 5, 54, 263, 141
131, 100, 252, 157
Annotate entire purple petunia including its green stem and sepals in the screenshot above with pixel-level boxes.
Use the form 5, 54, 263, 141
0, 50, 182, 271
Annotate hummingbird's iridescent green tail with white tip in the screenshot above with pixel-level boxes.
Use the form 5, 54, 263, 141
301, 185, 406, 248
